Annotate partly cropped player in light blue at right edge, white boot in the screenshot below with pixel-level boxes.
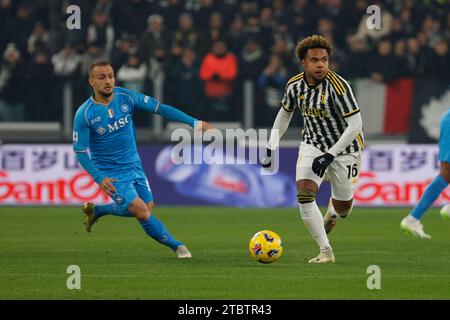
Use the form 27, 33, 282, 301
400, 110, 450, 239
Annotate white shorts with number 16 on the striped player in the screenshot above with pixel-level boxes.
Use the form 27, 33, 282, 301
296, 143, 361, 201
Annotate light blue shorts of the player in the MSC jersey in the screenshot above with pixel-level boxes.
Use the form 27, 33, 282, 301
108, 168, 153, 209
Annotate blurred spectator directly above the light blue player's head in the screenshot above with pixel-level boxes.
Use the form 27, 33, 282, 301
87, 11, 114, 59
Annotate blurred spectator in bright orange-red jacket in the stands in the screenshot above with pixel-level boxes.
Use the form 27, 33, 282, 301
200, 40, 238, 121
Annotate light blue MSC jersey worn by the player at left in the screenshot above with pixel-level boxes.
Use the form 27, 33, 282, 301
73, 87, 159, 174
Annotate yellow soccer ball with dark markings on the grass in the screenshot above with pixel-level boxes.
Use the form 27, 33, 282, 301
249, 230, 283, 263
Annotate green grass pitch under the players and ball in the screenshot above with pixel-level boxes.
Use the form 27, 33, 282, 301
0, 207, 450, 300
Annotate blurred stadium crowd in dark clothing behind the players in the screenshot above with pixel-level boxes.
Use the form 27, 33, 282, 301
0, 0, 450, 125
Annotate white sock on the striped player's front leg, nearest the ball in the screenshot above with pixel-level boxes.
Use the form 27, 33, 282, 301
298, 201, 331, 249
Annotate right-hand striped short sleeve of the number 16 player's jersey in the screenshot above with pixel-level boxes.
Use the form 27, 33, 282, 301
330, 73, 360, 118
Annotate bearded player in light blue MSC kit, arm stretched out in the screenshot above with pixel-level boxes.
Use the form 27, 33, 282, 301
73, 61, 212, 258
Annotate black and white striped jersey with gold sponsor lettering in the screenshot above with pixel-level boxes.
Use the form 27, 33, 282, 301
281, 70, 364, 154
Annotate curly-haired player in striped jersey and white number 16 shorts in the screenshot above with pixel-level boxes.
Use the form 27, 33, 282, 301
262, 35, 364, 263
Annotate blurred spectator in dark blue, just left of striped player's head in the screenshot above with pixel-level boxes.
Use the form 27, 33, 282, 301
256, 54, 289, 126
